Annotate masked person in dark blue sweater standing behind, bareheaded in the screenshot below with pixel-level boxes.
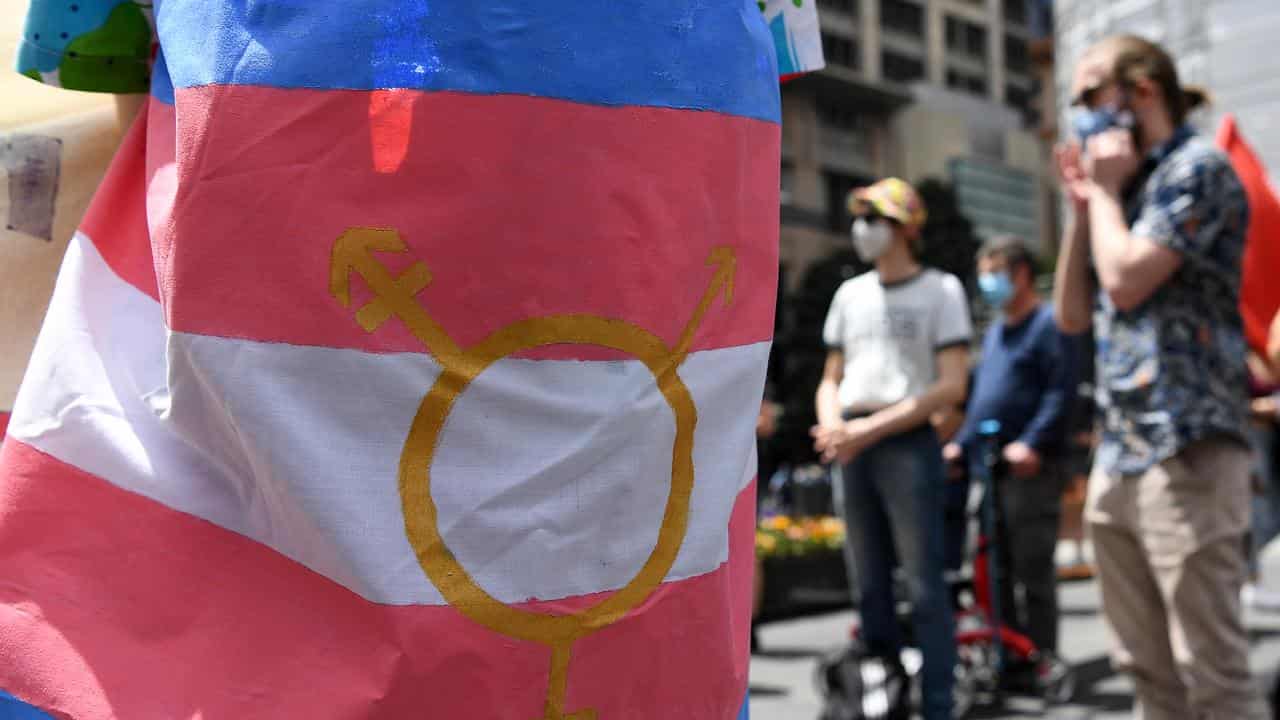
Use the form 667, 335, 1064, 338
943, 237, 1076, 653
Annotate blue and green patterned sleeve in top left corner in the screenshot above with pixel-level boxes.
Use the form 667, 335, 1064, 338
17, 0, 155, 94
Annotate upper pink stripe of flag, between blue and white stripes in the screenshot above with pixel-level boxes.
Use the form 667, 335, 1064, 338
144, 86, 780, 357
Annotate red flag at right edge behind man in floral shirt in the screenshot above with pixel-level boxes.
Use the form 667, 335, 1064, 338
1216, 115, 1280, 354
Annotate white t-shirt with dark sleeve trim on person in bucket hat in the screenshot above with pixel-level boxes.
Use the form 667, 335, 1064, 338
823, 269, 972, 411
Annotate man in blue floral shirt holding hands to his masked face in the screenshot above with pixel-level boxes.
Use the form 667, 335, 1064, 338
1056, 36, 1267, 720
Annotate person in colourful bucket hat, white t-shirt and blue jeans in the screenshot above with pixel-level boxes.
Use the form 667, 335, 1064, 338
813, 178, 972, 720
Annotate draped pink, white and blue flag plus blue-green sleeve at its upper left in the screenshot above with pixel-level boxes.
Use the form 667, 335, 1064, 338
0, 0, 780, 720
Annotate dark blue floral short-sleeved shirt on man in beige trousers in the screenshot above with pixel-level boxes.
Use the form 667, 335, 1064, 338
1093, 127, 1249, 475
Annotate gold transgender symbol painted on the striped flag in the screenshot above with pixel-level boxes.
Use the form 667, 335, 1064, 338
329, 227, 737, 720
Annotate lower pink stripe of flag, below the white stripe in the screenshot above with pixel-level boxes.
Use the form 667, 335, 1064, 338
0, 438, 755, 720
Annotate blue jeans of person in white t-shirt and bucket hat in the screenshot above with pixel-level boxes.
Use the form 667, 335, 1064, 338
840, 425, 956, 720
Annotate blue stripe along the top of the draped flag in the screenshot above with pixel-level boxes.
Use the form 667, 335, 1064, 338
149, 0, 780, 122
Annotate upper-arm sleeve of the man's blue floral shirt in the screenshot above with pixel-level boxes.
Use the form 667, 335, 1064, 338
1132, 152, 1248, 259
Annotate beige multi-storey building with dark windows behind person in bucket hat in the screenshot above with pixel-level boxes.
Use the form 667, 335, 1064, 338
782, 0, 1053, 292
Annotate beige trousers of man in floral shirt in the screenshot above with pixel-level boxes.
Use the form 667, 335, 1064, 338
1084, 439, 1270, 720
